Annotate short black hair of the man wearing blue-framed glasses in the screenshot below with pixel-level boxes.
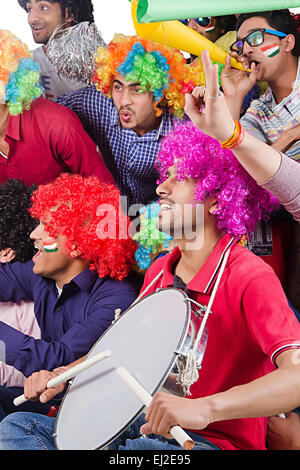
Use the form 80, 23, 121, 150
236, 9, 300, 57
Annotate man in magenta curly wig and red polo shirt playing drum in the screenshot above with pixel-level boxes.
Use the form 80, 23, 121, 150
0, 53, 300, 450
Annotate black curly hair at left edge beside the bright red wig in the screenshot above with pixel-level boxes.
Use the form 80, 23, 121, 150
0, 179, 38, 263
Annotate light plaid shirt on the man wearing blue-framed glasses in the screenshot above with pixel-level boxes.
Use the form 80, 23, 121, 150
241, 60, 300, 160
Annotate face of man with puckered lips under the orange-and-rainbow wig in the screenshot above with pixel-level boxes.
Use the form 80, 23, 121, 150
112, 74, 160, 135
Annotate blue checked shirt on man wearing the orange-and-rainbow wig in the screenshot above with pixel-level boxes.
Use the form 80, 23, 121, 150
57, 87, 176, 205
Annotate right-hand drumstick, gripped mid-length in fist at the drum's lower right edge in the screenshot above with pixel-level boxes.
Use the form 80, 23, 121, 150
117, 367, 194, 450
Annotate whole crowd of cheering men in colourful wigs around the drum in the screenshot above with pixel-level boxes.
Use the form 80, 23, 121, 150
0, 0, 300, 450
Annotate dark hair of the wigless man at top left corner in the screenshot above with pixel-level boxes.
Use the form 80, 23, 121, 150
18, 0, 94, 26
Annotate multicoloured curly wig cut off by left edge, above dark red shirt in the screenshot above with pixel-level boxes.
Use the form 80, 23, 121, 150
0, 30, 42, 116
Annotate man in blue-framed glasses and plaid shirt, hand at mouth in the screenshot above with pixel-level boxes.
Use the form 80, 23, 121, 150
222, 10, 300, 160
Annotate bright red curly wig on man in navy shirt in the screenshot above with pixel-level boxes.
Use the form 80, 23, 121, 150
30, 174, 137, 280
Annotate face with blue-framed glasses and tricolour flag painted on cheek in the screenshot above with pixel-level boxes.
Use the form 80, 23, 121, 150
237, 16, 291, 81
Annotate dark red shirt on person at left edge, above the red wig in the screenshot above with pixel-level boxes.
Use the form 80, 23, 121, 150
0, 98, 114, 185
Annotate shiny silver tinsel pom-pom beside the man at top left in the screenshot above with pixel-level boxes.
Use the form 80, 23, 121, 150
46, 21, 106, 85
